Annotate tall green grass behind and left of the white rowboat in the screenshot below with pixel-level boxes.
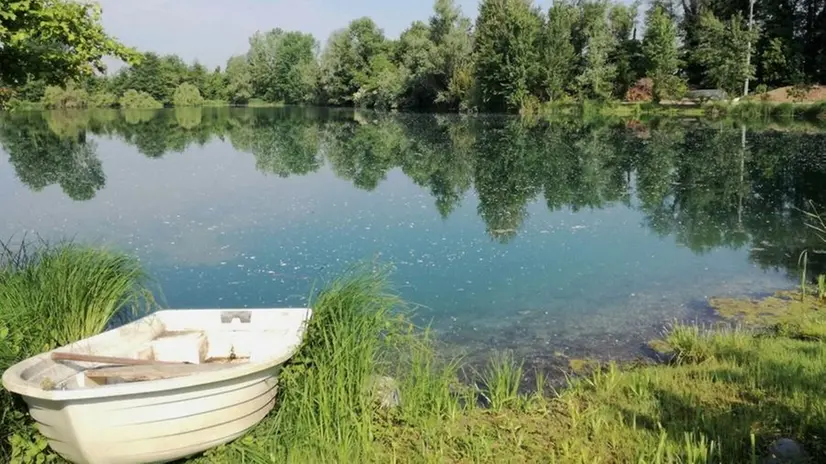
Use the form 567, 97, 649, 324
0, 240, 154, 462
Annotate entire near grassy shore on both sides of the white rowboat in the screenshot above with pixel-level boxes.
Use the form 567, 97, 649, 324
0, 246, 826, 463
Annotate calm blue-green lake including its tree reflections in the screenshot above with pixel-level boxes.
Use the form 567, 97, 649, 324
0, 108, 826, 359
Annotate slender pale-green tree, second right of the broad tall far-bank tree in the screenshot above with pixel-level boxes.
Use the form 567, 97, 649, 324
574, 0, 617, 100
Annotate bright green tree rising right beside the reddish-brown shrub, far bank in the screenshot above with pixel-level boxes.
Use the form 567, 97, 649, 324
642, 6, 684, 101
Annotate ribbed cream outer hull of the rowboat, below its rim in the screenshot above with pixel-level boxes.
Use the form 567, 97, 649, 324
23, 367, 279, 464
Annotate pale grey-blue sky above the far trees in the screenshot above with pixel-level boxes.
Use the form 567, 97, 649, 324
98, 0, 551, 70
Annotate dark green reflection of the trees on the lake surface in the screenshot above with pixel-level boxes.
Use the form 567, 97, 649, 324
0, 108, 826, 280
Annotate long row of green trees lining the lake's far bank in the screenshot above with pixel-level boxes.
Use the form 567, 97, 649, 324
4, 0, 826, 111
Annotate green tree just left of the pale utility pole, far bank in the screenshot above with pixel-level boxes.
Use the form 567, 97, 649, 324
695, 11, 756, 95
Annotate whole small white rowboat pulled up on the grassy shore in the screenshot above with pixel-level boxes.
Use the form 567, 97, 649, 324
3, 308, 312, 464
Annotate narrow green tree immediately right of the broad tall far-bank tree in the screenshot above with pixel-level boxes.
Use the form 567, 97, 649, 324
542, 0, 579, 101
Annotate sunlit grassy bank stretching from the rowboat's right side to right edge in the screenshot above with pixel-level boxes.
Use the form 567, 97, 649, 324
199, 280, 826, 463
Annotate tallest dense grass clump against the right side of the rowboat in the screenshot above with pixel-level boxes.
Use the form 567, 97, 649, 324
206, 268, 404, 462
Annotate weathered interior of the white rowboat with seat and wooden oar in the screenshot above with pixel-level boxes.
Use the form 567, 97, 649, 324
12, 310, 308, 390
